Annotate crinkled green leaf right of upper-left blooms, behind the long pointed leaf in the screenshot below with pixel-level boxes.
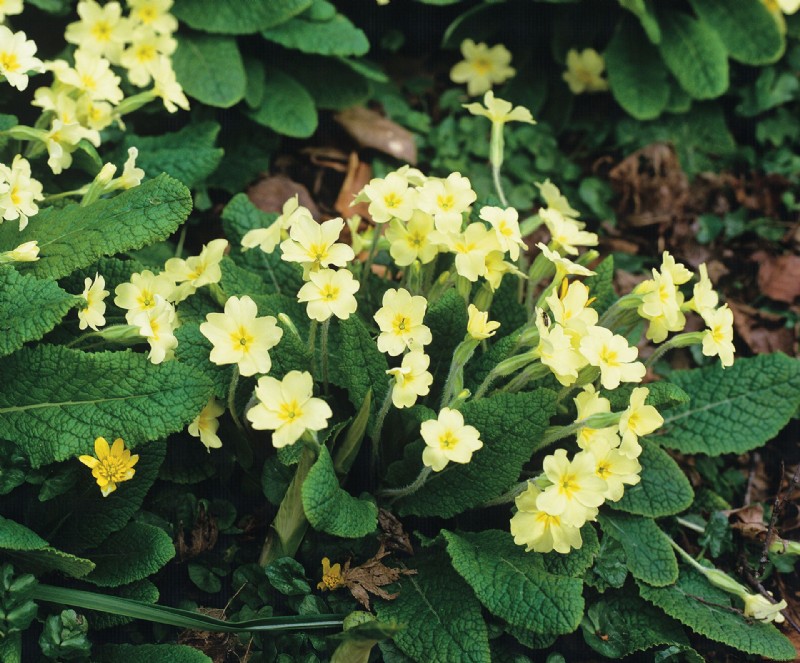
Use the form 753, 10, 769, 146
122, 122, 224, 187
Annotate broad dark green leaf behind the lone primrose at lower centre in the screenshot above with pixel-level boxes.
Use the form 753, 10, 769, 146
398, 389, 555, 518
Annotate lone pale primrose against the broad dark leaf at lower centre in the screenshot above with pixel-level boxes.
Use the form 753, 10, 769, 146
420, 407, 483, 472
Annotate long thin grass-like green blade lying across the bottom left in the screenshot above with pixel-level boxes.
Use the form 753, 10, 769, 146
32, 584, 344, 633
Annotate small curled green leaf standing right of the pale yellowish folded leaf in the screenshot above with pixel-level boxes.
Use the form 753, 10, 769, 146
303, 447, 378, 539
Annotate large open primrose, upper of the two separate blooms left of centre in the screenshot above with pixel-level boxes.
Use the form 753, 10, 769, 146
200, 295, 283, 376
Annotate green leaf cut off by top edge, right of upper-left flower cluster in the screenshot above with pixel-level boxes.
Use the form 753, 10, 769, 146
172, 0, 312, 35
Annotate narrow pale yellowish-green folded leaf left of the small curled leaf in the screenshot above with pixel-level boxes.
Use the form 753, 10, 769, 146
258, 438, 319, 566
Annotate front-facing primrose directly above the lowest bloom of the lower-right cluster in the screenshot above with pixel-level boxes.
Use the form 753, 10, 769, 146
536, 449, 608, 527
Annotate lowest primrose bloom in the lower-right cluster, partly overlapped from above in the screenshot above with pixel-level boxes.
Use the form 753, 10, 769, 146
510, 482, 583, 554
